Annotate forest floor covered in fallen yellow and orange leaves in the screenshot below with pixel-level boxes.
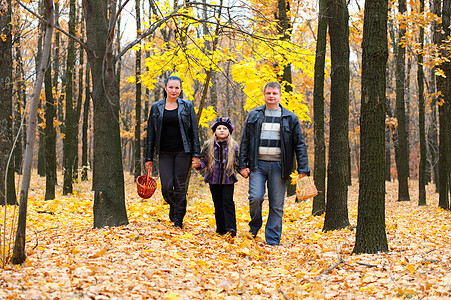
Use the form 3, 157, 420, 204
0, 174, 451, 300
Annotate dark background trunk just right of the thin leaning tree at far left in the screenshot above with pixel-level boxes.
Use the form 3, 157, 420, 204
44, 55, 57, 200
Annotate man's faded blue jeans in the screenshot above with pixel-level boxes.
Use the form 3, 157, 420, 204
249, 160, 286, 245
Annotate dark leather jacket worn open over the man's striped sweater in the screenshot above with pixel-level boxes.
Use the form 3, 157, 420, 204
240, 105, 310, 180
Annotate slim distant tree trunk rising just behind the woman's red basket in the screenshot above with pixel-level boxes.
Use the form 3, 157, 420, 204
133, 1, 142, 180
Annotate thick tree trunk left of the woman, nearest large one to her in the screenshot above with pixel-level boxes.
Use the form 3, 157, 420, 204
83, 0, 128, 228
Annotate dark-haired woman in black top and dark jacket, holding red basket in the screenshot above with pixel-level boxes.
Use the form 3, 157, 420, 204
145, 76, 200, 228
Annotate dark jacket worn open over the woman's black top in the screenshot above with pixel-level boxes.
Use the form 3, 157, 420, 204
146, 98, 200, 161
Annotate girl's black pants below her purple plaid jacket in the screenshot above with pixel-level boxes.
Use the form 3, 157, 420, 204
210, 184, 236, 235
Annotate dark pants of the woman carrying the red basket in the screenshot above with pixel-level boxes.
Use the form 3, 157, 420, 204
159, 151, 191, 227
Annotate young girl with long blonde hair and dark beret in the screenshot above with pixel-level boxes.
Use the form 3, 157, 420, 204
197, 118, 239, 237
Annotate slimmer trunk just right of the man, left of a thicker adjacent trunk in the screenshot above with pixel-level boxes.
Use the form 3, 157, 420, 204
312, 0, 328, 216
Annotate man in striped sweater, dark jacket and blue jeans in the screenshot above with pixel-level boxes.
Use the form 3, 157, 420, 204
240, 82, 310, 245
